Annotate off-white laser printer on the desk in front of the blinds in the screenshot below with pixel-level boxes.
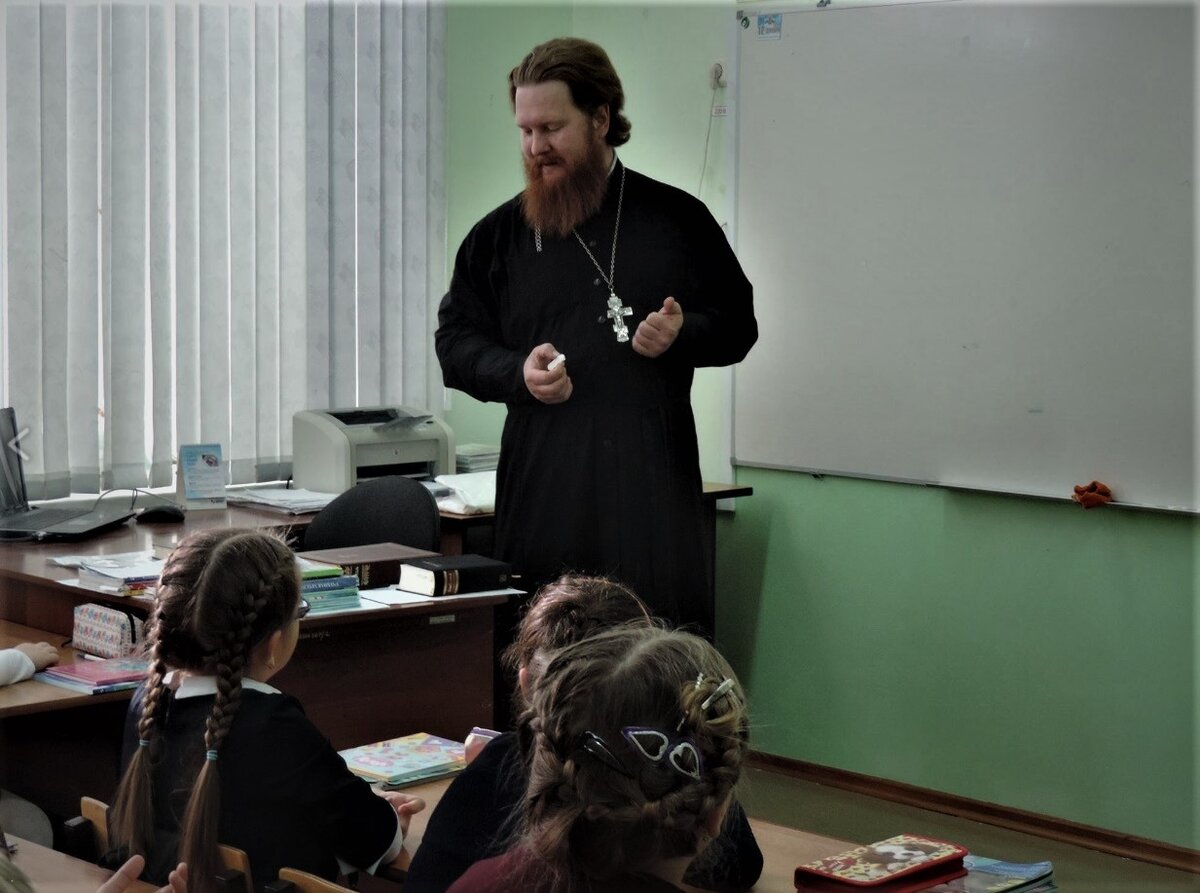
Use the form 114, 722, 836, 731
292, 406, 455, 493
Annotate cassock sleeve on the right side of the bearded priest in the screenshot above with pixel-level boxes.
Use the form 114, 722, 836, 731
671, 197, 758, 366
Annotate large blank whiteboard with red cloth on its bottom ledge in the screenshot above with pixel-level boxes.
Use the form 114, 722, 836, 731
733, 2, 1198, 510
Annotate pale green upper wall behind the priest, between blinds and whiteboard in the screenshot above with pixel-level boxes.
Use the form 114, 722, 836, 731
445, 4, 733, 480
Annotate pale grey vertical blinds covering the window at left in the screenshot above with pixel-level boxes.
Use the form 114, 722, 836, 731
0, 0, 445, 498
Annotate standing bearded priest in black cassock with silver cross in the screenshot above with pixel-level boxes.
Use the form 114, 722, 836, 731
436, 38, 758, 635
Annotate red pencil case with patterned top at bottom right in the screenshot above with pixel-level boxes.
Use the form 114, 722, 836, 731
796, 834, 967, 893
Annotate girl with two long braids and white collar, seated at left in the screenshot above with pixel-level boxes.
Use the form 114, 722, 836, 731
110, 528, 425, 893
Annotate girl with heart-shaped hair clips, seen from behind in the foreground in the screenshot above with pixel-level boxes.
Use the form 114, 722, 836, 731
450, 625, 748, 893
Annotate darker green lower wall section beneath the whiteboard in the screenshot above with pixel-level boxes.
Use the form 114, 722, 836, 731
718, 468, 1200, 846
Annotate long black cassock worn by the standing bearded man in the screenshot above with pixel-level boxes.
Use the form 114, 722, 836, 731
436, 162, 758, 630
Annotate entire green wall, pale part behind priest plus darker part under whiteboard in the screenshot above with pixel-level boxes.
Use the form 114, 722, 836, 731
446, 4, 1200, 847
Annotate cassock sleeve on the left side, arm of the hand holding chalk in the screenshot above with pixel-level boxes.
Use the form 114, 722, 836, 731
433, 212, 534, 403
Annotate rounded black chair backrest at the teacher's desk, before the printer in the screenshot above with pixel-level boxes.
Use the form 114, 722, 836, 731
304, 475, 442, 552
